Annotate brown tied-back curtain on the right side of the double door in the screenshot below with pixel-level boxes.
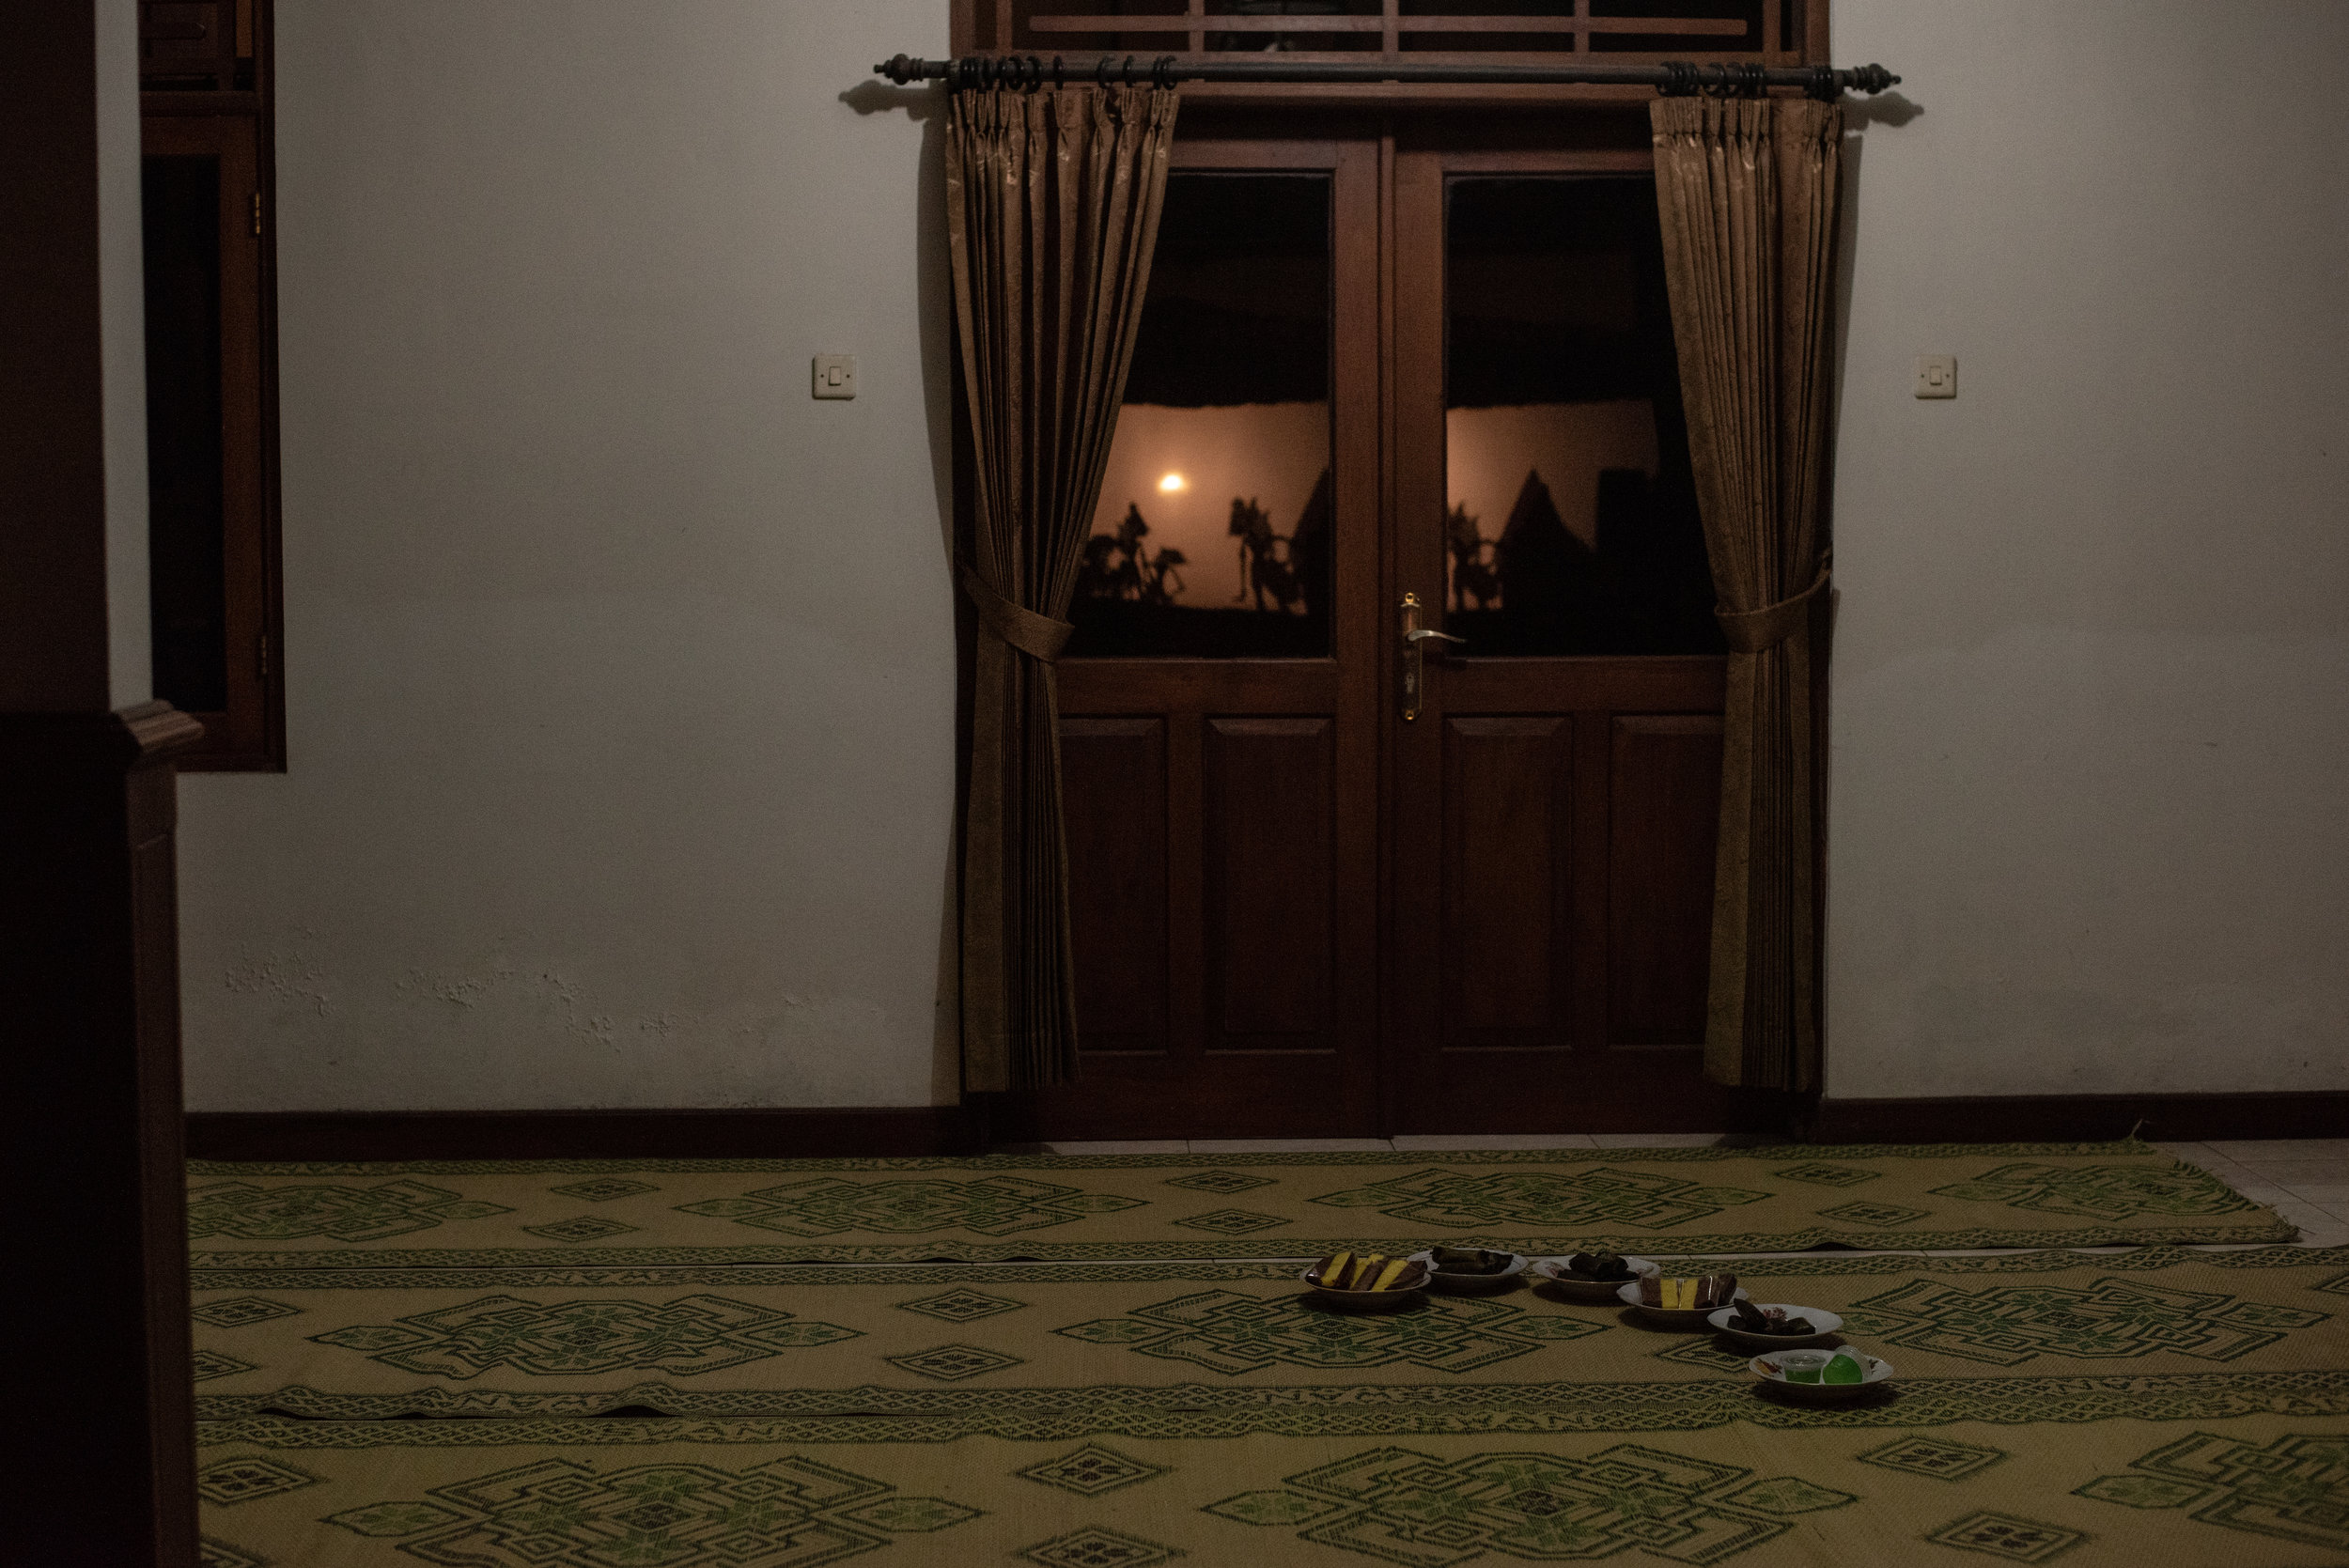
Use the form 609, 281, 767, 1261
1652, 99, 1844, 1089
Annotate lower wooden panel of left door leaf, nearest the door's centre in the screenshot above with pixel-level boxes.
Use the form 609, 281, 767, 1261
1207, 716, 1337, 1051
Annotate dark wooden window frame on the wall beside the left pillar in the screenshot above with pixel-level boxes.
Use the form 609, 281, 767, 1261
139, 0, 287, 772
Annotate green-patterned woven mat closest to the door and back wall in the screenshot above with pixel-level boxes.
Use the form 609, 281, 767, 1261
188, 1143, 2297, 1267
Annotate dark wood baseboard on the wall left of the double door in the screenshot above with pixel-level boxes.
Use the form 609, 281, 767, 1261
188, 1106, 987, 1159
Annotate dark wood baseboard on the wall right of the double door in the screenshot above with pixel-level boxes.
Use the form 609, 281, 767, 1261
1804, 1089, 2349, 1143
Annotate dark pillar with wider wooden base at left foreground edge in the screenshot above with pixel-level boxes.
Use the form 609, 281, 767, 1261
0, 5, 197, 1568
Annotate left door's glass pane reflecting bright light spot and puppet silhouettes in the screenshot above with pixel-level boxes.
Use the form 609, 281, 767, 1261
1066, 171, 1337, 660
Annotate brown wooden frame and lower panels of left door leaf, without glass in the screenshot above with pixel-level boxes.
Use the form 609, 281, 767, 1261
1019, 132, 1381, 1139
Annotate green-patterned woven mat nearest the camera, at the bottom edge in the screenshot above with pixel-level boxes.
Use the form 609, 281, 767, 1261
197, 1413, 2349, 1568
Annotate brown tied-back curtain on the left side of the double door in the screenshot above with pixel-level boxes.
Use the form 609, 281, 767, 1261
947, 86, 1174, 1089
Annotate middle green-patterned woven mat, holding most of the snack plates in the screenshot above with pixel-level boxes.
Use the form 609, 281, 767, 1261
195, 1247, 2349, 1436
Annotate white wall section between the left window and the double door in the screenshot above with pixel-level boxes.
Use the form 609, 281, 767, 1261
181, 0, 954, 1110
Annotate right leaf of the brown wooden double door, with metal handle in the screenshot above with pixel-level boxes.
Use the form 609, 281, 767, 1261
1384, 138, 1755, 1134
